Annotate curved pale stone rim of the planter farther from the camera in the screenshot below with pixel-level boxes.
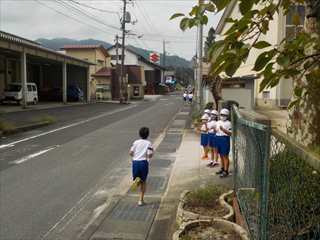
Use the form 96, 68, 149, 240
176, 190, 234, 226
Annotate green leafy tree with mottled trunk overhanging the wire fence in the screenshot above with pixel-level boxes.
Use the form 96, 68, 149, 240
172, 0, 320, 146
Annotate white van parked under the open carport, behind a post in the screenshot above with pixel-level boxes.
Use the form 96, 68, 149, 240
1, 83, 38, 104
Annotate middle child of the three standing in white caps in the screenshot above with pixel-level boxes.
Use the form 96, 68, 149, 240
207, 110, 219, 167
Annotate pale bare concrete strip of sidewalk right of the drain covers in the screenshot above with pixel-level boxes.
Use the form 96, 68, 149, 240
148, 129, 233, 240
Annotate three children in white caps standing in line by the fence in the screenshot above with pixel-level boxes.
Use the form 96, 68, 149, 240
201, 108, 232, 178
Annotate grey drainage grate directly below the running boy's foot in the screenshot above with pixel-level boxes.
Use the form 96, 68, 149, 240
108, 200, 159, 222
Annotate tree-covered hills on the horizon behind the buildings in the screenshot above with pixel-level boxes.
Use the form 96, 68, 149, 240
36, 38, 193, 86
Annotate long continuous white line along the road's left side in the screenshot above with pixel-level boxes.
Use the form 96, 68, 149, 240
0, 105, 137, 149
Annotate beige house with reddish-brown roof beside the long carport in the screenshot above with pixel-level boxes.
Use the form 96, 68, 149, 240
62, 45, 112, 100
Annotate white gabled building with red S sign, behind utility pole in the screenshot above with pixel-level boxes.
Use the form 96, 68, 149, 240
108, 45, 165, 94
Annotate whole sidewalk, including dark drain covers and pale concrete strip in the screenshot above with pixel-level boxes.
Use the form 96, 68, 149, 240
80, 106, 232, 240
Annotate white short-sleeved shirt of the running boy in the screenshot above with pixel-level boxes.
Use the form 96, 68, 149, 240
130, 139, 153, 161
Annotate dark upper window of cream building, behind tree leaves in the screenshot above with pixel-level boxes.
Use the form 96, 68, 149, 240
286, 5, 305, 39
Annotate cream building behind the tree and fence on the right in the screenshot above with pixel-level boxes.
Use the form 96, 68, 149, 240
205, 1, 304, 108
